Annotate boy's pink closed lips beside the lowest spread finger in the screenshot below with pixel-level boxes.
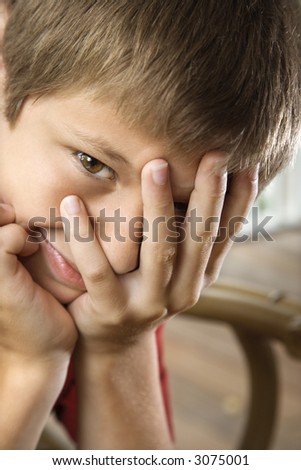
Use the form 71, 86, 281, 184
42, 239, 86, 291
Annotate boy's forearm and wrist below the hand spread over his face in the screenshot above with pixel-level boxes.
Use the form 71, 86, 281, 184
75, 331, 170, 449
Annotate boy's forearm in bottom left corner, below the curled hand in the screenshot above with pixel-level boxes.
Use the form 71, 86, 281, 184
0, 357, 67, 449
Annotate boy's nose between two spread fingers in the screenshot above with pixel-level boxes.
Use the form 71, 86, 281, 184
90, 193, 143, 274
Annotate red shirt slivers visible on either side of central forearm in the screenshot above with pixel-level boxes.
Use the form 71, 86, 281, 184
54, 325, 173, 441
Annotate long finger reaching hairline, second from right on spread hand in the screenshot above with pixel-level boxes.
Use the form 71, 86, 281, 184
171, 152, 227, 310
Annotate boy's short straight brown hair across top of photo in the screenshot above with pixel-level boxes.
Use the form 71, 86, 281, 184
0, 0, 301, 185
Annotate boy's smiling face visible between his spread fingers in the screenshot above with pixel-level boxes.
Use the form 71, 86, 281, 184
0, 93, 199, 303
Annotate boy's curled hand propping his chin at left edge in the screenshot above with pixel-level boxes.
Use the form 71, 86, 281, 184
0, 204, 77, 363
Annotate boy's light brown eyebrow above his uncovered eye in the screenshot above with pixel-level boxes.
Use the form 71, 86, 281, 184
64, 125, 131, 165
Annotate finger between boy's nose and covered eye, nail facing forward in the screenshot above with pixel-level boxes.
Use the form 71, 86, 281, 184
139, 159, 176, 302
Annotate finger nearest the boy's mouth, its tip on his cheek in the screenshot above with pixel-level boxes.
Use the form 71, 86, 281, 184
60, 196, 118, 305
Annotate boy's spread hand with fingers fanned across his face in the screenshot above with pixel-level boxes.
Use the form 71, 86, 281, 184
61, 152, 258, 345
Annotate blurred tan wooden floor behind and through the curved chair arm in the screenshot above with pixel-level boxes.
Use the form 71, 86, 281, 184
165, 230, 301, 449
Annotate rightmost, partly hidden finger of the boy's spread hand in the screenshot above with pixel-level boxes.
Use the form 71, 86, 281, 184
206, 166, 258, 283
